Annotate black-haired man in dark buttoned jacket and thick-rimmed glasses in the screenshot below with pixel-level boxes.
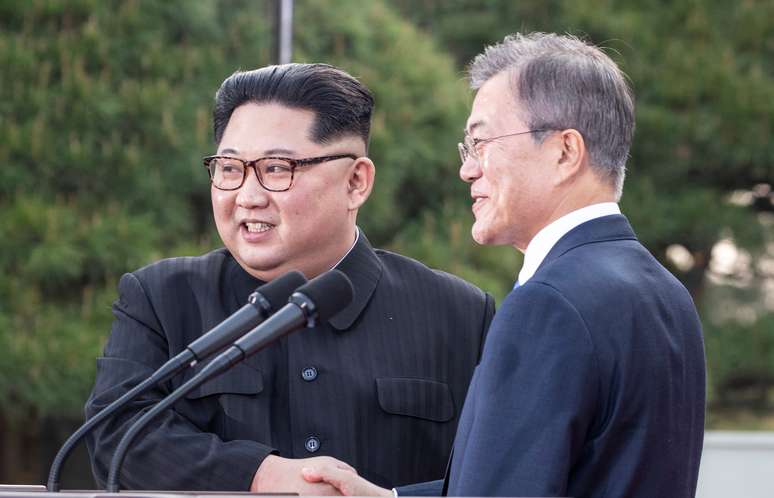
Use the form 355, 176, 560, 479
86, 64, 493, 495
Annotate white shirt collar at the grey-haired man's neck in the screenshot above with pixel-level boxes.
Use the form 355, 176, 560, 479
518, 202, 621, 285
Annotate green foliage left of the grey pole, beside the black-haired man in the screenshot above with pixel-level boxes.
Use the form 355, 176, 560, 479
0, 0, 278, 415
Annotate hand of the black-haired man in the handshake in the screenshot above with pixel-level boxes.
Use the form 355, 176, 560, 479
250, 455, 357, 496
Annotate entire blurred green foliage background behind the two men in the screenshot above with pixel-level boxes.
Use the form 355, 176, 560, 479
0, 0, 774, 482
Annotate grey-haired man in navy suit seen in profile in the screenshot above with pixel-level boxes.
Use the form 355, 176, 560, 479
304, 33, 705, 498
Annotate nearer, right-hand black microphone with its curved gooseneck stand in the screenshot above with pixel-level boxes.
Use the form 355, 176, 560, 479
105, 270, 354, 493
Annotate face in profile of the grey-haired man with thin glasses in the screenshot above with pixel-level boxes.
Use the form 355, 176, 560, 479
460, 72, 559, 251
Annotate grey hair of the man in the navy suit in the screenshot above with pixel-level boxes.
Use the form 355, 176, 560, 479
469, 33, 634, 198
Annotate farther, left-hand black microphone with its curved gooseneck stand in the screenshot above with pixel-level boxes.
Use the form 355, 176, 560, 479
46, 271, 306, 492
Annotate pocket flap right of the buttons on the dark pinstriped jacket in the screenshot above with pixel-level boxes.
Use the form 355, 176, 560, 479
376, 377, 455, 422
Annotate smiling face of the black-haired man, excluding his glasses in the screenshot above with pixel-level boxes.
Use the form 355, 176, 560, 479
211, 103, 373, 281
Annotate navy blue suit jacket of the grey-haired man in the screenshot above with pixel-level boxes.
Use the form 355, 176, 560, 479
399, 215, 705, 498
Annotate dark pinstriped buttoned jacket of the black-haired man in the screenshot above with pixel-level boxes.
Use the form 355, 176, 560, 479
86, 233, 494, 491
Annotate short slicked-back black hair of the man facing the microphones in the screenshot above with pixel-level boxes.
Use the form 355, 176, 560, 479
212, 64, 374, 147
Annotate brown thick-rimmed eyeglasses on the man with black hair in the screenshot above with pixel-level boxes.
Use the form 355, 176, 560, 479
203, 154, 357, 192
